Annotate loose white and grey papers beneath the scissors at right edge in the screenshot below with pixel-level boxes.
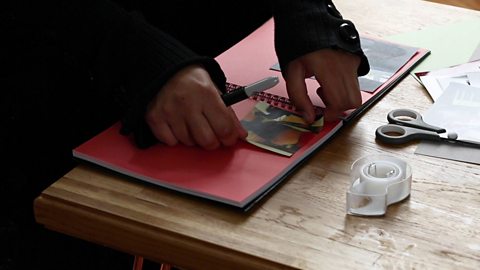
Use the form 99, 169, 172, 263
416, 61, 480, 164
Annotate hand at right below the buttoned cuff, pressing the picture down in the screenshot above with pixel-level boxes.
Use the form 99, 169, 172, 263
285, 49, 362, 123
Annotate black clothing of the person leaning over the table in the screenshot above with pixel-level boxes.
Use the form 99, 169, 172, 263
0, 0, 368, 269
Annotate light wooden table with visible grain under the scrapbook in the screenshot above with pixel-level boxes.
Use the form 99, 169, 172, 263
35, 0, 480, 269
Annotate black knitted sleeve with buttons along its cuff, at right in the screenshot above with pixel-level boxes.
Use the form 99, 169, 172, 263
271, 0, 369, 75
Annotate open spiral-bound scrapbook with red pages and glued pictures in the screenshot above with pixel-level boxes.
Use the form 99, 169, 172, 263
73, 20, 428, 210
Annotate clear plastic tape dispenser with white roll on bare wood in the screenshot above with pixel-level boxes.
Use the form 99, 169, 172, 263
347, 155, 412, 216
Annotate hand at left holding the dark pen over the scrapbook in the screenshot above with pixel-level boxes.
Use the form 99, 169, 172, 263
145, 65, 247, 150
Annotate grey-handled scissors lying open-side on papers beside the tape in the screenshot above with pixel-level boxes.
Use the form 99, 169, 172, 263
375, 109, 480, 148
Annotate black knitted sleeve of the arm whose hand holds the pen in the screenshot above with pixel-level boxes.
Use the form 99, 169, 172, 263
40, 0, 226, 148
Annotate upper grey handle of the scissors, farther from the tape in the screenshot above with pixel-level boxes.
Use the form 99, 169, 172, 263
387, 109, 446, 133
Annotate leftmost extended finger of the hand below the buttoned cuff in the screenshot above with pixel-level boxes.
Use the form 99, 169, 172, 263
286, 61, 315, 123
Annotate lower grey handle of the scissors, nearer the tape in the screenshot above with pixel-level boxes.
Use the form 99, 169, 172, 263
375, 124, 441, 144
